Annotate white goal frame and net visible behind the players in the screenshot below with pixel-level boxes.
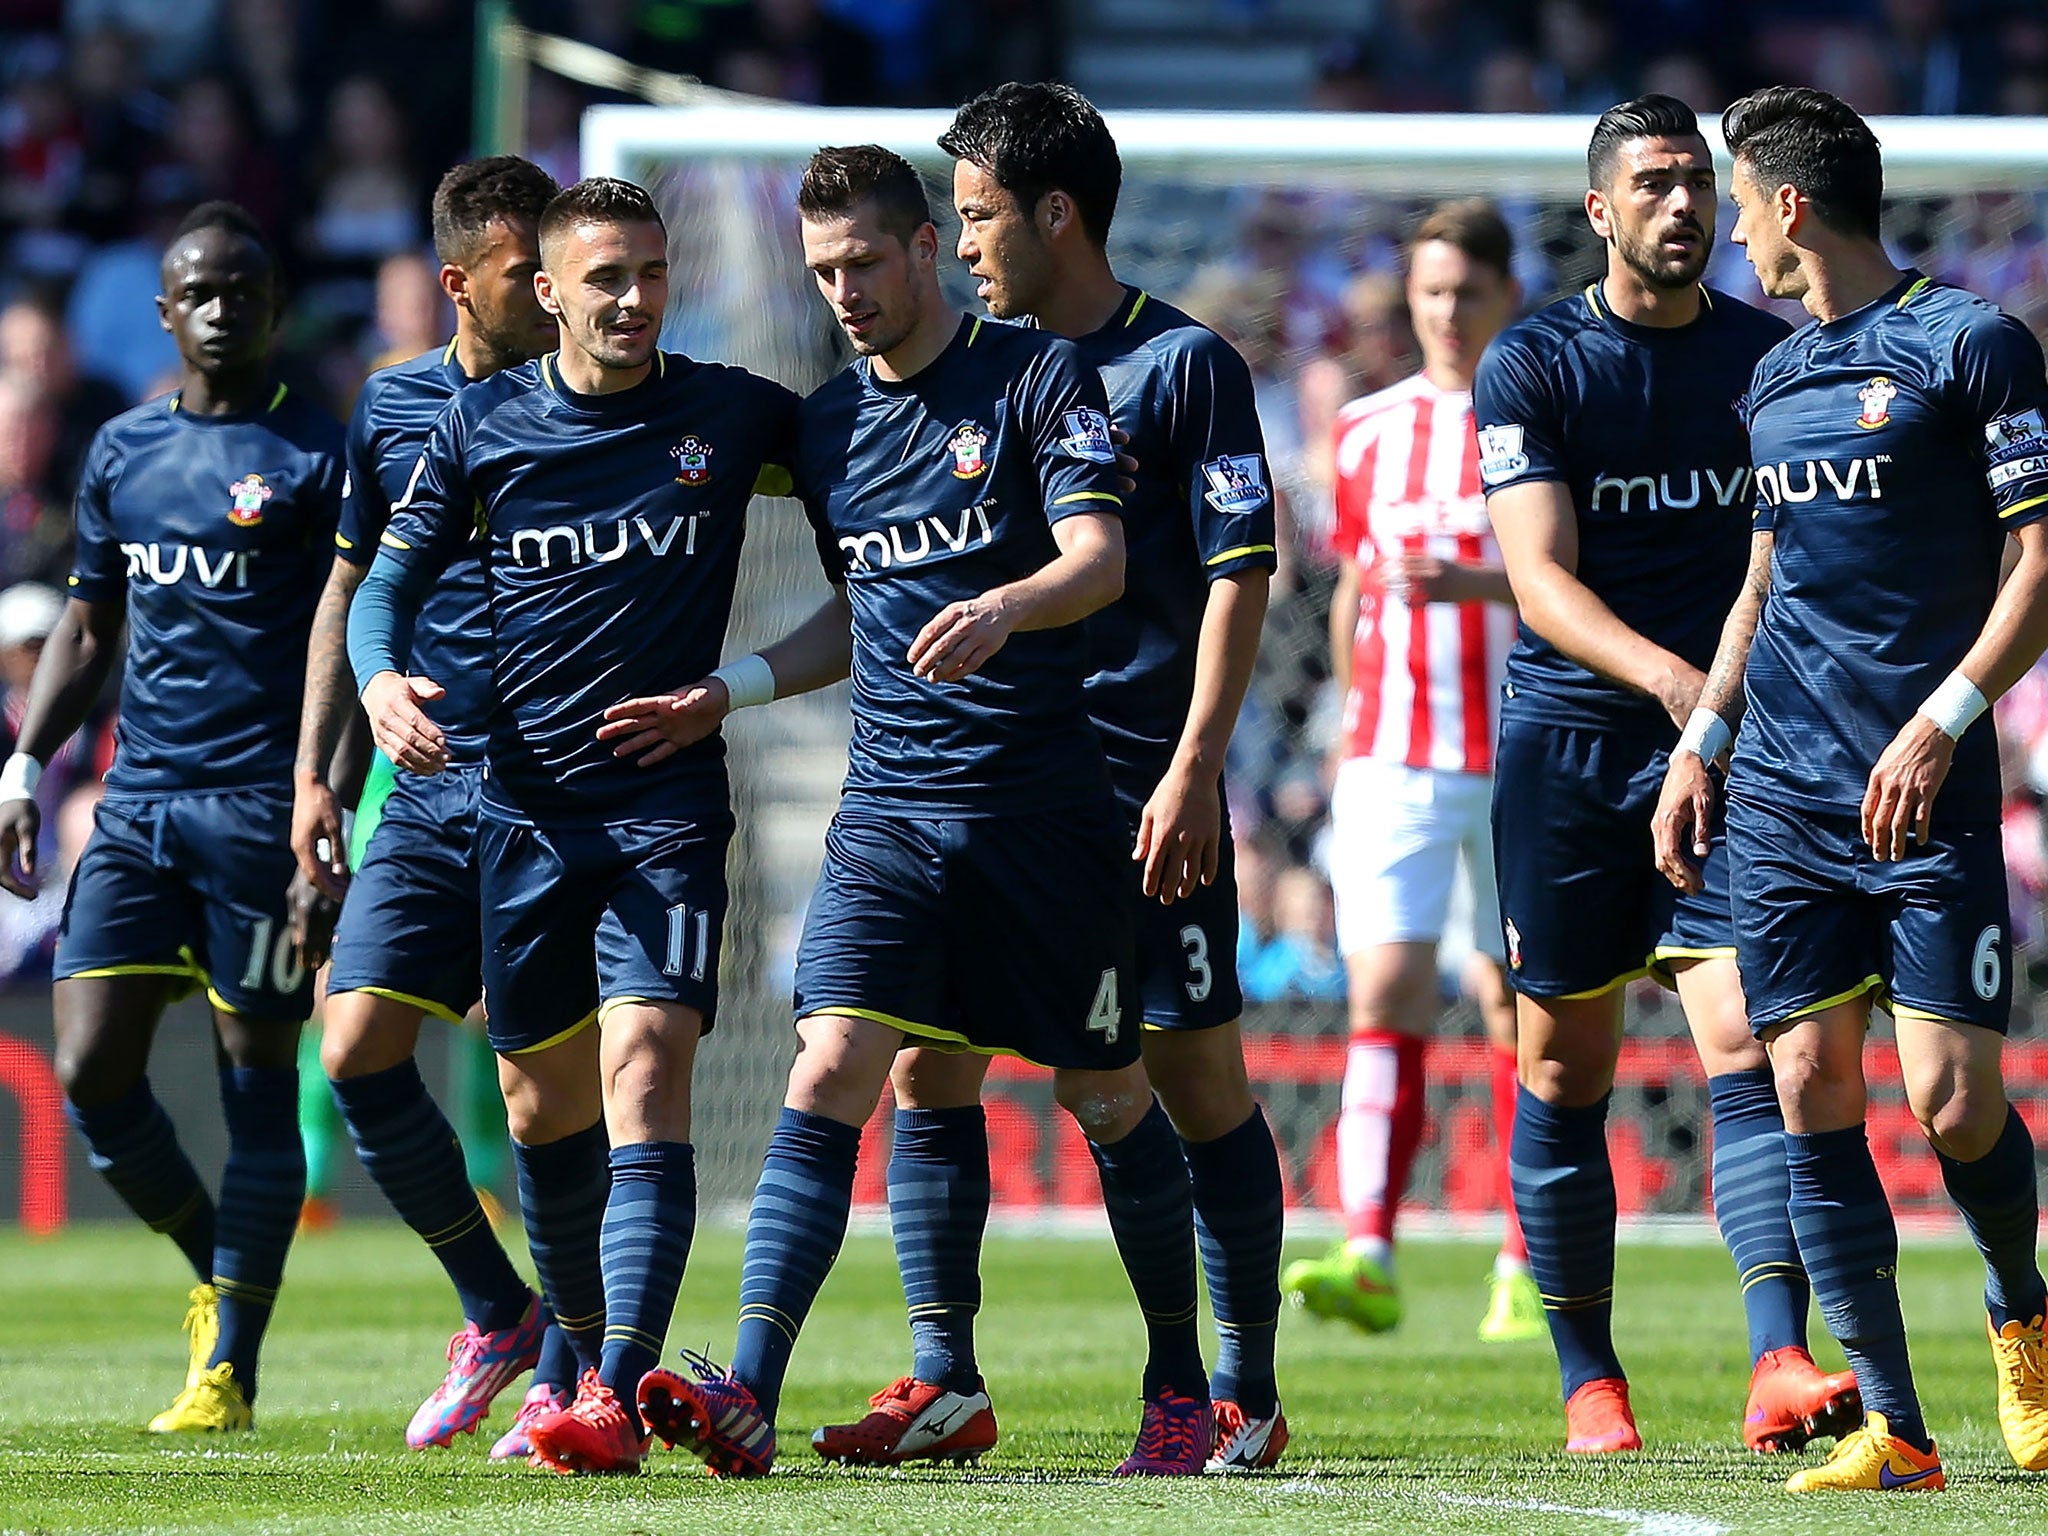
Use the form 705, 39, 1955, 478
584, 102, 2048, 1227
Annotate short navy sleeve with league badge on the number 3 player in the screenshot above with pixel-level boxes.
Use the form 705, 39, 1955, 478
1169, 332, 1278, 582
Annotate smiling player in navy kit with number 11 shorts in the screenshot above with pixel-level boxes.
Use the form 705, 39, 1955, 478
344, 178, 797, 1473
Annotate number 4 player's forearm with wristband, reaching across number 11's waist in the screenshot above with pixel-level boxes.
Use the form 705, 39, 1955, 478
598, 584, 854, 768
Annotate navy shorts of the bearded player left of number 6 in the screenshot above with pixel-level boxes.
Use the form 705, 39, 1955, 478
1493, 721, 1735, 997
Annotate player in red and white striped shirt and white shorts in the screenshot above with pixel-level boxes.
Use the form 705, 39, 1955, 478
1282, 199, 1544, 1341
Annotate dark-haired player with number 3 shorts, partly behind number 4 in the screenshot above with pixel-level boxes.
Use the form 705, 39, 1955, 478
811, 84, 1286, 1470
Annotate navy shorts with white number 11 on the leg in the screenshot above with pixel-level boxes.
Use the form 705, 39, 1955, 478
477, 813, 733, 1055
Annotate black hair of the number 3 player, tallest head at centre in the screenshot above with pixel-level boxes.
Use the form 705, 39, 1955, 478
938, 80, 1124, 246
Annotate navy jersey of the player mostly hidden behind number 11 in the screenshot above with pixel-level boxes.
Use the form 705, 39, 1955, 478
334, 342, 492, 764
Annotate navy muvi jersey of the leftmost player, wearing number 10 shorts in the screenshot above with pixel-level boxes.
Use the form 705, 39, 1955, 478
70, 385, 344, 793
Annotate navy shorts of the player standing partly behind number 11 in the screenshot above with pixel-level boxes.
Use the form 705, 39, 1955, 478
328, 768, 483, 1024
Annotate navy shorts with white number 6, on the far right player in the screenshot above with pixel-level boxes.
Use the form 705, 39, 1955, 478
1729, 799, 2013, 1034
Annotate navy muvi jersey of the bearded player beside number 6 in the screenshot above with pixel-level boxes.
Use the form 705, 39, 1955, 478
1473, 283, 1790, 733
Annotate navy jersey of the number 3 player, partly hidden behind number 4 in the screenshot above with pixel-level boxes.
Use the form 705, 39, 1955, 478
1073, 287, 1276, 805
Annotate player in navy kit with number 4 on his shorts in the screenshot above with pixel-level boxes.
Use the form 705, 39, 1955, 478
638, 145, 1210, 1475
